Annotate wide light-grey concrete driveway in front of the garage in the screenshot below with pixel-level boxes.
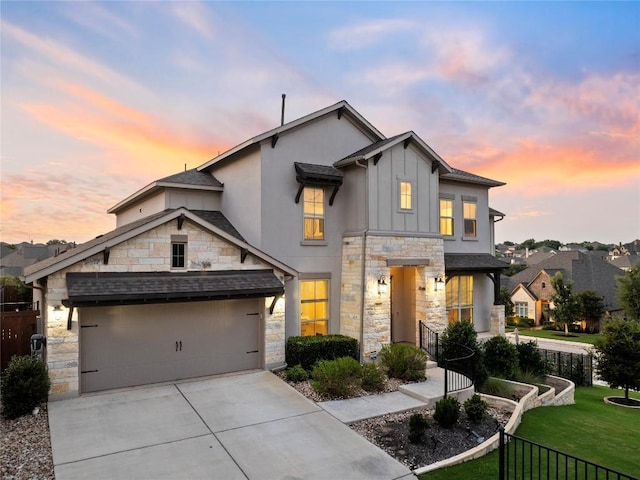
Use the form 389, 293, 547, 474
49, 371, 414, 480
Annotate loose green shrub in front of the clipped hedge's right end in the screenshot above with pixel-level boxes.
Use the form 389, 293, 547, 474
311, 357, 362, 398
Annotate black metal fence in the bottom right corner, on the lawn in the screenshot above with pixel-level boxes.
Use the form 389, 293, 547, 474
498, 427, 640, 480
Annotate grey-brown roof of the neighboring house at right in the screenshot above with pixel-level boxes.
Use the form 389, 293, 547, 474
509, 251, 624, 309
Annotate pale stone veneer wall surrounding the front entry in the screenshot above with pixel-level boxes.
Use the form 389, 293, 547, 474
340, 234, 447, 358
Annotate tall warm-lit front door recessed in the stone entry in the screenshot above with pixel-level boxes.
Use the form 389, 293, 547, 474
391, 267, 416, 345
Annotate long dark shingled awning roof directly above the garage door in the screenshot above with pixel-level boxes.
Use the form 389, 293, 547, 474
67, 270, 284, 306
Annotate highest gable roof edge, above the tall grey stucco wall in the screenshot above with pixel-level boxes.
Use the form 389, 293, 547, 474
197, 100, 385, 172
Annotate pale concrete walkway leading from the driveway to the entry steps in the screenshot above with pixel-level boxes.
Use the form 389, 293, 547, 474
318, 366, 473, 424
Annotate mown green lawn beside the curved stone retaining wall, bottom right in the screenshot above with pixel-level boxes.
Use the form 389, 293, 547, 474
420, 387, 640, 480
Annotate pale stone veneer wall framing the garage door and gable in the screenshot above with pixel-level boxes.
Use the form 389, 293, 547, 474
44, 221, 285, 400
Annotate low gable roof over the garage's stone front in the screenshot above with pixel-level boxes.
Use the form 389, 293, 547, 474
24, 207, 297, 283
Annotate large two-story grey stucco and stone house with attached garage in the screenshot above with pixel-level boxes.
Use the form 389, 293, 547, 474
26, 101, 505, 397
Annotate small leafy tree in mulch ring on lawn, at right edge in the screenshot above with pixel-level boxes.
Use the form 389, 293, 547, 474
595, 320, 640, 400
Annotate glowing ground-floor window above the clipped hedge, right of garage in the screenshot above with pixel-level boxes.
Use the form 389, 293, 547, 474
300, 280, 329, 336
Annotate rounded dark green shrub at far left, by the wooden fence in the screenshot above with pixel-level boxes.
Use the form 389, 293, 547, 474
0, 355, 51, 418
